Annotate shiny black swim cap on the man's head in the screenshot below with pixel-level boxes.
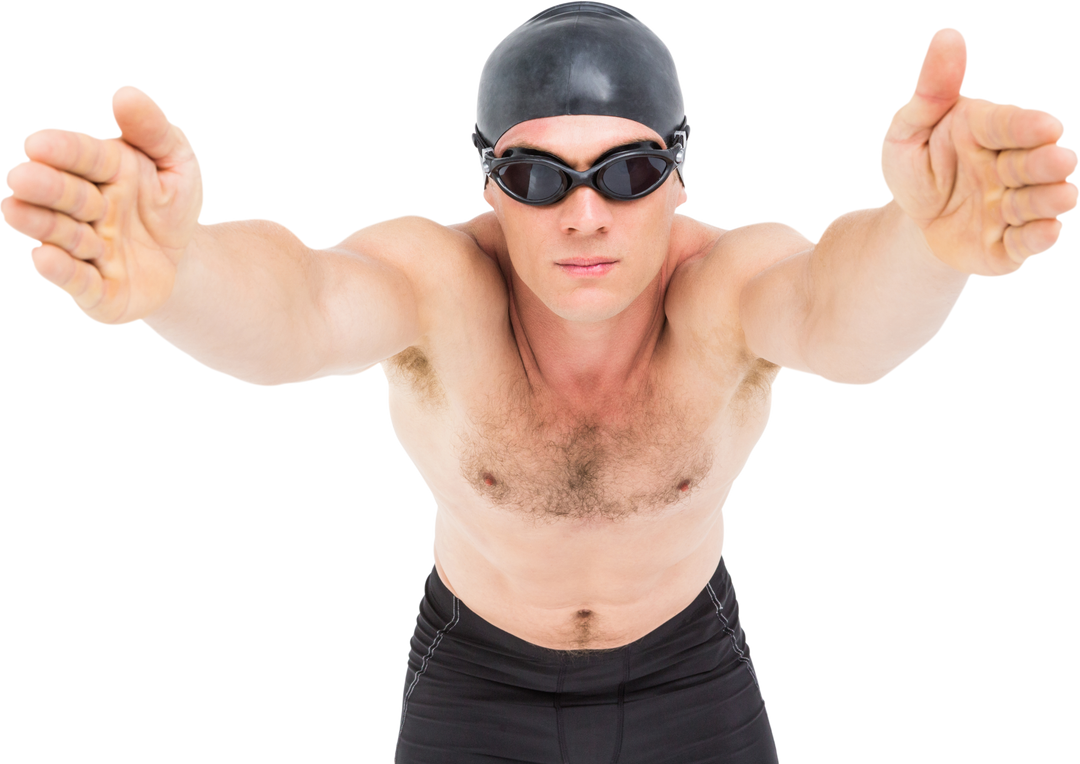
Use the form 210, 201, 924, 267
473, 0, 693, 191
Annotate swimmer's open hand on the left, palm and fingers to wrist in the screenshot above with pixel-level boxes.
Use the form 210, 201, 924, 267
0, 83, 206, 327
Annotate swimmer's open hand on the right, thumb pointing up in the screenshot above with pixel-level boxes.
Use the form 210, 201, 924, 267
878, 26, 1080, 279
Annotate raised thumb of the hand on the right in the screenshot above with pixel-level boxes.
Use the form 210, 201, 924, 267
897, 24, 971, 137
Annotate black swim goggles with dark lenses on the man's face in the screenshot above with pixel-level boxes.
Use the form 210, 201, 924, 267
469, 120, 693, 205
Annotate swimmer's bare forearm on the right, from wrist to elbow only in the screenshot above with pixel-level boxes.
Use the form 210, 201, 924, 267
804, 202, 971, 387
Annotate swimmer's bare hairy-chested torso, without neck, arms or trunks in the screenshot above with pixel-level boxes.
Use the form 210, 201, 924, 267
379, 213, 781, 649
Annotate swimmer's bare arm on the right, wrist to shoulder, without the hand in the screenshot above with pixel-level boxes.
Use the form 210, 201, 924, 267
740, 202, 971, 387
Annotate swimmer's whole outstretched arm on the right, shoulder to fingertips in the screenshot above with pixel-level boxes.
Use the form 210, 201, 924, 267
742, 26, 1080, 387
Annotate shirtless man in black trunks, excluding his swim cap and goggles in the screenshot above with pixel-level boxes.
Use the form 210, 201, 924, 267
0, 1, 1078, 764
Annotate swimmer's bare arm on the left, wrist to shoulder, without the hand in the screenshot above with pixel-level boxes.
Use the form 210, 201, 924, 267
143, 216, 425, 389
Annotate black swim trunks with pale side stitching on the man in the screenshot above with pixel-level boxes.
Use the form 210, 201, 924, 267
393, 557, 780, 764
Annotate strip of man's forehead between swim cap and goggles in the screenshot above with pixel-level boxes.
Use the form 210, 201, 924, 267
495, 115, 665, 159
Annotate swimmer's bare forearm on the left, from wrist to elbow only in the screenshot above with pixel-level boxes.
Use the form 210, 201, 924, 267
143, 217, 318, 388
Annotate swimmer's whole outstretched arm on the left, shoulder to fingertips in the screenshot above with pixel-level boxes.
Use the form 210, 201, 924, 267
0, 83, 434, 388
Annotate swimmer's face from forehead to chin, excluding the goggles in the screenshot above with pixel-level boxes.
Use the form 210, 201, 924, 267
484, 116, 690, 322
